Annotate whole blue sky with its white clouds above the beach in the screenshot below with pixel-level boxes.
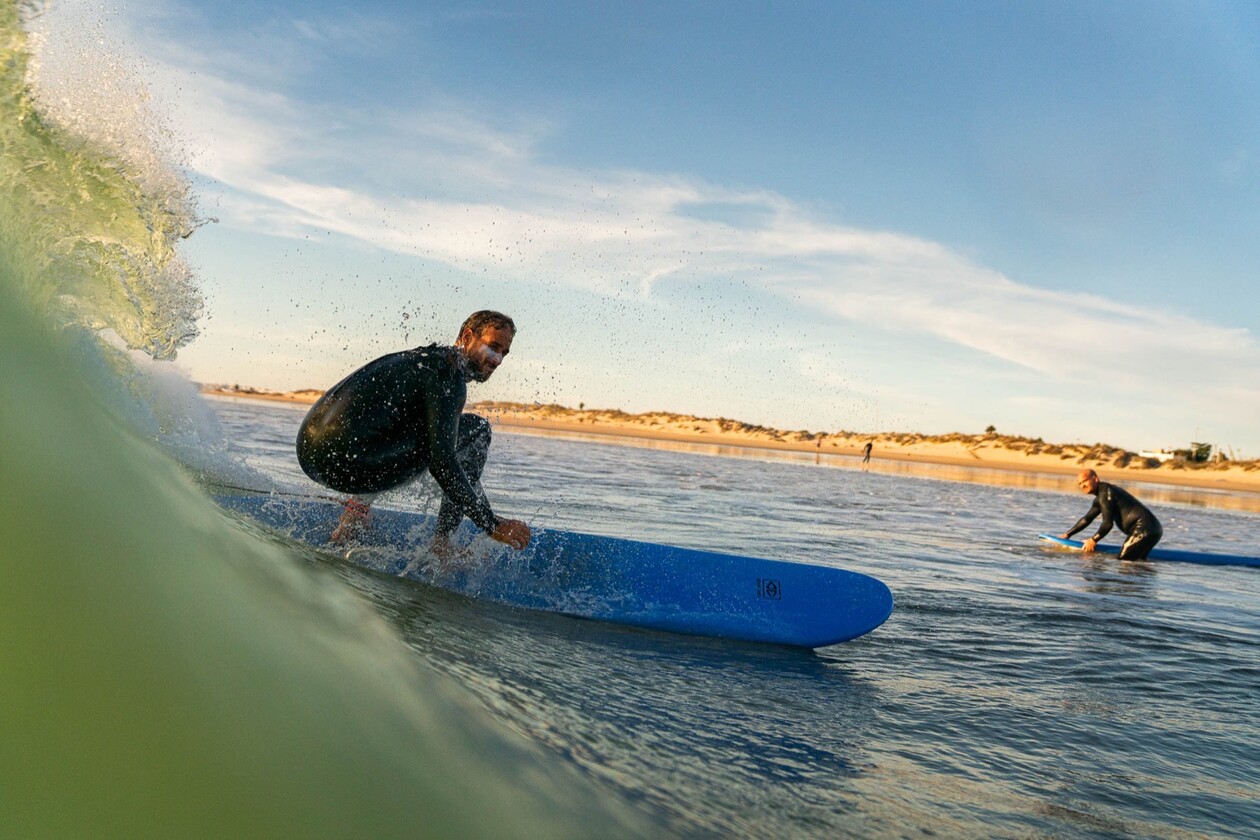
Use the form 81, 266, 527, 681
34, 0, 1260, 457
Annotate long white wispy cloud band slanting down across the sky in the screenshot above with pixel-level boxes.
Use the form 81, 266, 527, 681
185, 63, 1260, 367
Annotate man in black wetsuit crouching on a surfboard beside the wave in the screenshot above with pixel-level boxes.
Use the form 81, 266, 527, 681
297, 310, 530, 555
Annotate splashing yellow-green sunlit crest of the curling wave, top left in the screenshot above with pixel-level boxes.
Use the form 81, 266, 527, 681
0, 0, 204, 359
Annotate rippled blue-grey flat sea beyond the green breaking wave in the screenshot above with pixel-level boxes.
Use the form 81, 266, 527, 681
199, 400, 1260, 837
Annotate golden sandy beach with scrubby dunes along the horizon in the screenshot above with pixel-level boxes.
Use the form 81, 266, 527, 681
202, 385, 1260, 494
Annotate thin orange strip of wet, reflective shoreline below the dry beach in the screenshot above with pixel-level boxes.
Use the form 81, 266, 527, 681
498, 426, 1260, 513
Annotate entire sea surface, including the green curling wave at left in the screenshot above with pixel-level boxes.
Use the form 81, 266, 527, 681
0, 1, 1260, 839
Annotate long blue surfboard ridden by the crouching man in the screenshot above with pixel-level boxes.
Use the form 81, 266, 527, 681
214, 495, 892, 647
